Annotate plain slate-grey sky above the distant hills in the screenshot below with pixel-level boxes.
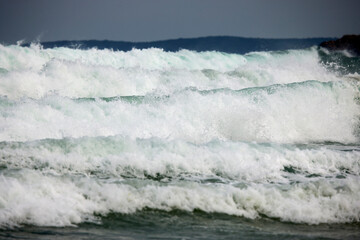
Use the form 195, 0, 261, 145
0, 0, 360, 44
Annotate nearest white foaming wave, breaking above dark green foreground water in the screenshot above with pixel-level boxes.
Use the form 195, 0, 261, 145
0, 170, 360, 227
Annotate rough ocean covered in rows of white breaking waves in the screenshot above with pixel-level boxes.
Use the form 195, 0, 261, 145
0, 39, 360, 239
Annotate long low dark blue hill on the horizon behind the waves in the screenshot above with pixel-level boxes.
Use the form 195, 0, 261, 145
25, 36, 334, 54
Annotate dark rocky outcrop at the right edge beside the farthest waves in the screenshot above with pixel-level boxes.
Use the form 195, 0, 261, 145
320, 35, 360, 56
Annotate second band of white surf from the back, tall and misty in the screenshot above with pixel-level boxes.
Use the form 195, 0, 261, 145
0, 82, 360, 143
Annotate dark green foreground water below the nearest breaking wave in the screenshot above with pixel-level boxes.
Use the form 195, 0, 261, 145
0, 210, 359, 239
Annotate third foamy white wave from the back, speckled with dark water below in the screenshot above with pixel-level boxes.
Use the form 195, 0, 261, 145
0, 137, 360, 184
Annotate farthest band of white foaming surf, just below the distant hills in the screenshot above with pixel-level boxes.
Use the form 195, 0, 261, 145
0, 45, 339, 99
